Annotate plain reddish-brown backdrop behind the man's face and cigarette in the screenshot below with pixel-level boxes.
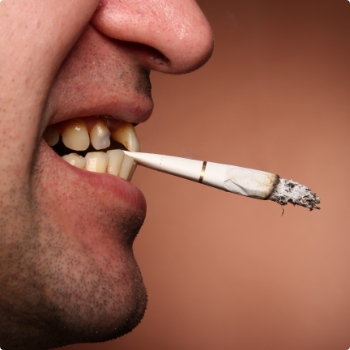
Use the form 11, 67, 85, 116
60, 0, 350, 350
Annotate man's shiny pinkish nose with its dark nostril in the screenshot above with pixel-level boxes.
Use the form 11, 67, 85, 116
92, 0, 214, 74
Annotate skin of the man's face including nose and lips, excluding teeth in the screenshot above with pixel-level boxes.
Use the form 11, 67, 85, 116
0, 0, 213, 350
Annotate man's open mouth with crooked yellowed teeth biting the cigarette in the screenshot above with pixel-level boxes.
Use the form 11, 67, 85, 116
43, 116, 140, 181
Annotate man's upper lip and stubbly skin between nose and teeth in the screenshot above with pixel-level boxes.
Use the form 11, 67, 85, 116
45, 27, 153, 131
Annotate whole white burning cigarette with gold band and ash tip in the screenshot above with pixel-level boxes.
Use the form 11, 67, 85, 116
124, 151, 320, 210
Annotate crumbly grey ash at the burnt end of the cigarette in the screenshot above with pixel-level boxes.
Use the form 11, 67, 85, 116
268, 179, 321, 210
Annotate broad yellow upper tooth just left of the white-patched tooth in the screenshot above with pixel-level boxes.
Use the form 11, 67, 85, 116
62, 119, 90, 151
